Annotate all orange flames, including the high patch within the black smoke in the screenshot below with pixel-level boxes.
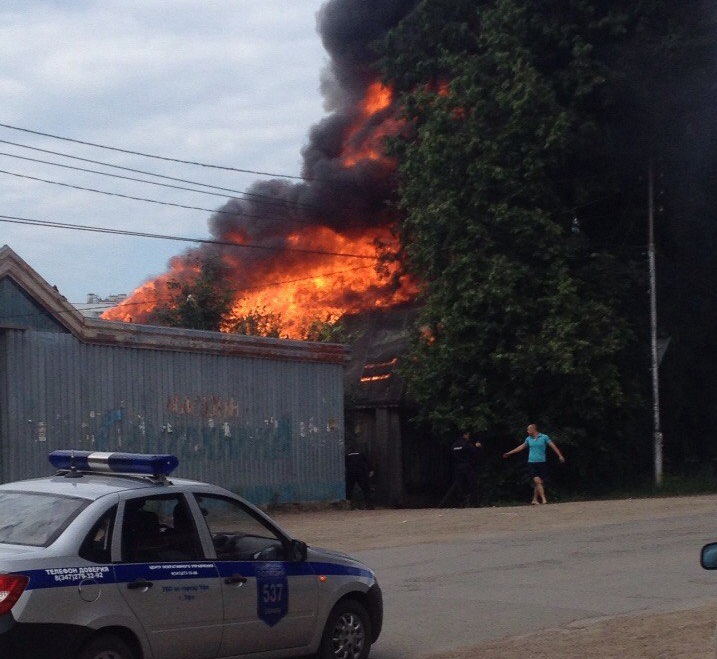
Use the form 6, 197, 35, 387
103, 82, 418, 338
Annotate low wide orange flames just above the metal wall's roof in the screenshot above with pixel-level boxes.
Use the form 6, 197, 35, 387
103, 226, 418, 339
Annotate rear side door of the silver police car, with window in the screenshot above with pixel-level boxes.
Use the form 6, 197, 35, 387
115, 494, 222, 659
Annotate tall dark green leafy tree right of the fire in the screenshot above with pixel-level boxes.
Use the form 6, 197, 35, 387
381, 0, 712, 490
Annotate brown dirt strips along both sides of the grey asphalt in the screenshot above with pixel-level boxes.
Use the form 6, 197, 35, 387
272, 496, 717, 659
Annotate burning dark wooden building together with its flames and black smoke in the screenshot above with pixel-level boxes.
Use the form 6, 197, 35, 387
98, 0, 444, 505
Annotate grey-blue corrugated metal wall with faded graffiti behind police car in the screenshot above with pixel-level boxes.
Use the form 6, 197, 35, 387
0, 329, 344, 503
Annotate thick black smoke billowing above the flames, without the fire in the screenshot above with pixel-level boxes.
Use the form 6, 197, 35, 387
178, 0, 416, 288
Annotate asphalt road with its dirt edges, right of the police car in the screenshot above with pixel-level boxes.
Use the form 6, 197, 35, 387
275, 496, 717, 659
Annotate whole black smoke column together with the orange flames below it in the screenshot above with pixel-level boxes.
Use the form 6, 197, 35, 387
103, 0, 418, 330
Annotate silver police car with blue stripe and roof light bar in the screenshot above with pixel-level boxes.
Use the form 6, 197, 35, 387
0, 451, 383, 659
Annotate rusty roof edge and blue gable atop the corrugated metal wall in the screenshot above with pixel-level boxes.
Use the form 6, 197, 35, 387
0, 245, 349, 364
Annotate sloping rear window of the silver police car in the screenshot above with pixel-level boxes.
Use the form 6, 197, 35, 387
0, 491, 89, 547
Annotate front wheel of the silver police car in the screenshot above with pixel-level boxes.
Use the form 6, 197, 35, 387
317, 599, 371, 659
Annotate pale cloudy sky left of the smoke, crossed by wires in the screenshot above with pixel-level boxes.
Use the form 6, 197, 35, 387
0, 0, 328, 303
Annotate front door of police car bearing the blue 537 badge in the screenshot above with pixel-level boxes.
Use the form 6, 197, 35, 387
196, 494, 318, 657
